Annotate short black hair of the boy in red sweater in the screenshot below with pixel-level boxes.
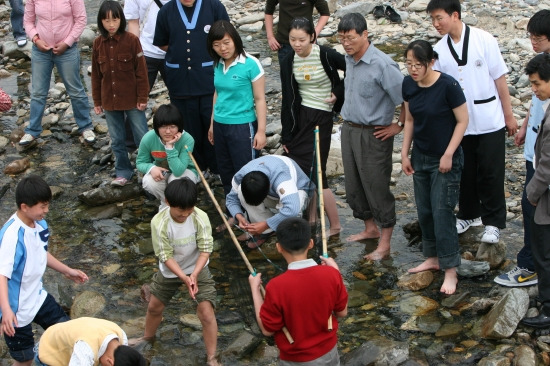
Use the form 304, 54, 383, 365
277, 217, 311, 253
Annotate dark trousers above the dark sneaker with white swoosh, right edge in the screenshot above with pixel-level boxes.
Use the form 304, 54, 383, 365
517, 160, 535, 271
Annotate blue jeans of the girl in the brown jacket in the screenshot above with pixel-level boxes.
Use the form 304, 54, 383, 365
105, 108, 147, 180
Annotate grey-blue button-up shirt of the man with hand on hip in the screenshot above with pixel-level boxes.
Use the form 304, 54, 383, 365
340, 43, 403, 126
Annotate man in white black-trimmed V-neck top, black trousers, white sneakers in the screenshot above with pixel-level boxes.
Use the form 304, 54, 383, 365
426, 0, 518, 243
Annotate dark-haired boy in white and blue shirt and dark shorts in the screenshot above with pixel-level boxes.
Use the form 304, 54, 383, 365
0, 175, 88, 366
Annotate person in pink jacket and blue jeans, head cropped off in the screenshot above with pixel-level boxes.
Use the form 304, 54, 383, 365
19, 0, 95, 146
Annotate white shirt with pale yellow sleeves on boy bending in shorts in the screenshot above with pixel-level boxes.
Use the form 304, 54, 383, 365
151, 207, 214, 278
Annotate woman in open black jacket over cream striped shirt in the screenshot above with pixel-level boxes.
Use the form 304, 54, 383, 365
281, 18, 346, 235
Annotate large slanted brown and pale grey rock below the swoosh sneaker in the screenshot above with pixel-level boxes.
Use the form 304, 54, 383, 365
473, 288, 529, 339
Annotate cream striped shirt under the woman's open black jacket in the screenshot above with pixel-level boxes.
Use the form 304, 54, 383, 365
292, 44, 332, 112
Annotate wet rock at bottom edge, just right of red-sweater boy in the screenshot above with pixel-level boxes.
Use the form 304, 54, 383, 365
341, 337, 409, 366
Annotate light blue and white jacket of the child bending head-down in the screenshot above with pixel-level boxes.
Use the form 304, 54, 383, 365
225, 155, 315, 230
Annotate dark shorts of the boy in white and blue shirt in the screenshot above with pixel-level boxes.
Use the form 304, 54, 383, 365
4, 294, 70, 362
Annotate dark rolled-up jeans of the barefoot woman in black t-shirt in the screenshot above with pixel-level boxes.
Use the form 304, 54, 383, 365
411, 147, 464, 269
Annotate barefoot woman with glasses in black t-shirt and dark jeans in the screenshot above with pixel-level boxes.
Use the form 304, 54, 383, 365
401, 40, 468, 295
